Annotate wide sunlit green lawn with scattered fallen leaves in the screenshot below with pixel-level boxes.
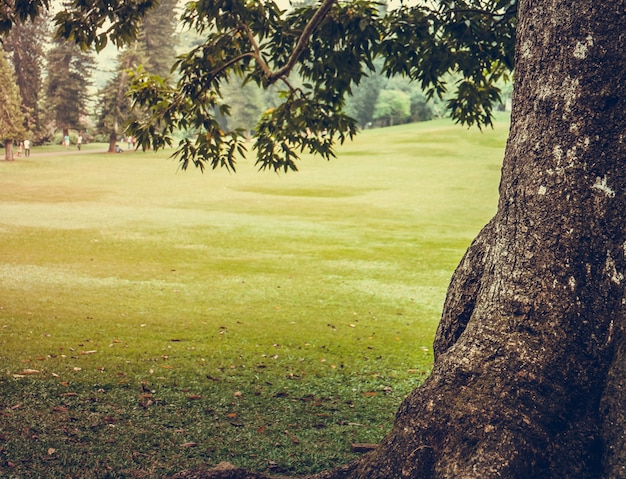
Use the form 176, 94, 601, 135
0, 121, 507, 478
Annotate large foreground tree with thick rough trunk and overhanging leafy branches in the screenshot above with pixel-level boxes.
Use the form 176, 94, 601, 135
2, 0, 626, 479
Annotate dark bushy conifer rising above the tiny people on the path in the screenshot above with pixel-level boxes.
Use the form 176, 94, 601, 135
45, 40, 95, 139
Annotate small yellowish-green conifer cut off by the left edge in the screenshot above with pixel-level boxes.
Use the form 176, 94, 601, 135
0, 47, 26, 161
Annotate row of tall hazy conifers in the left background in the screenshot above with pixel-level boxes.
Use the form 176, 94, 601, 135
0, 0, 178, 159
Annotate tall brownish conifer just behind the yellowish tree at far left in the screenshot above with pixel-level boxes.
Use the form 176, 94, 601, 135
4, 17, 48, 142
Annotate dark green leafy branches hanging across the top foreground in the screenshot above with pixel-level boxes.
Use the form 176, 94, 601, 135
0, 0, 517, 171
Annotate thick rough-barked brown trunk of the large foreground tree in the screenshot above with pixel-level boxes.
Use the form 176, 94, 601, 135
172, 0, 626, 479
